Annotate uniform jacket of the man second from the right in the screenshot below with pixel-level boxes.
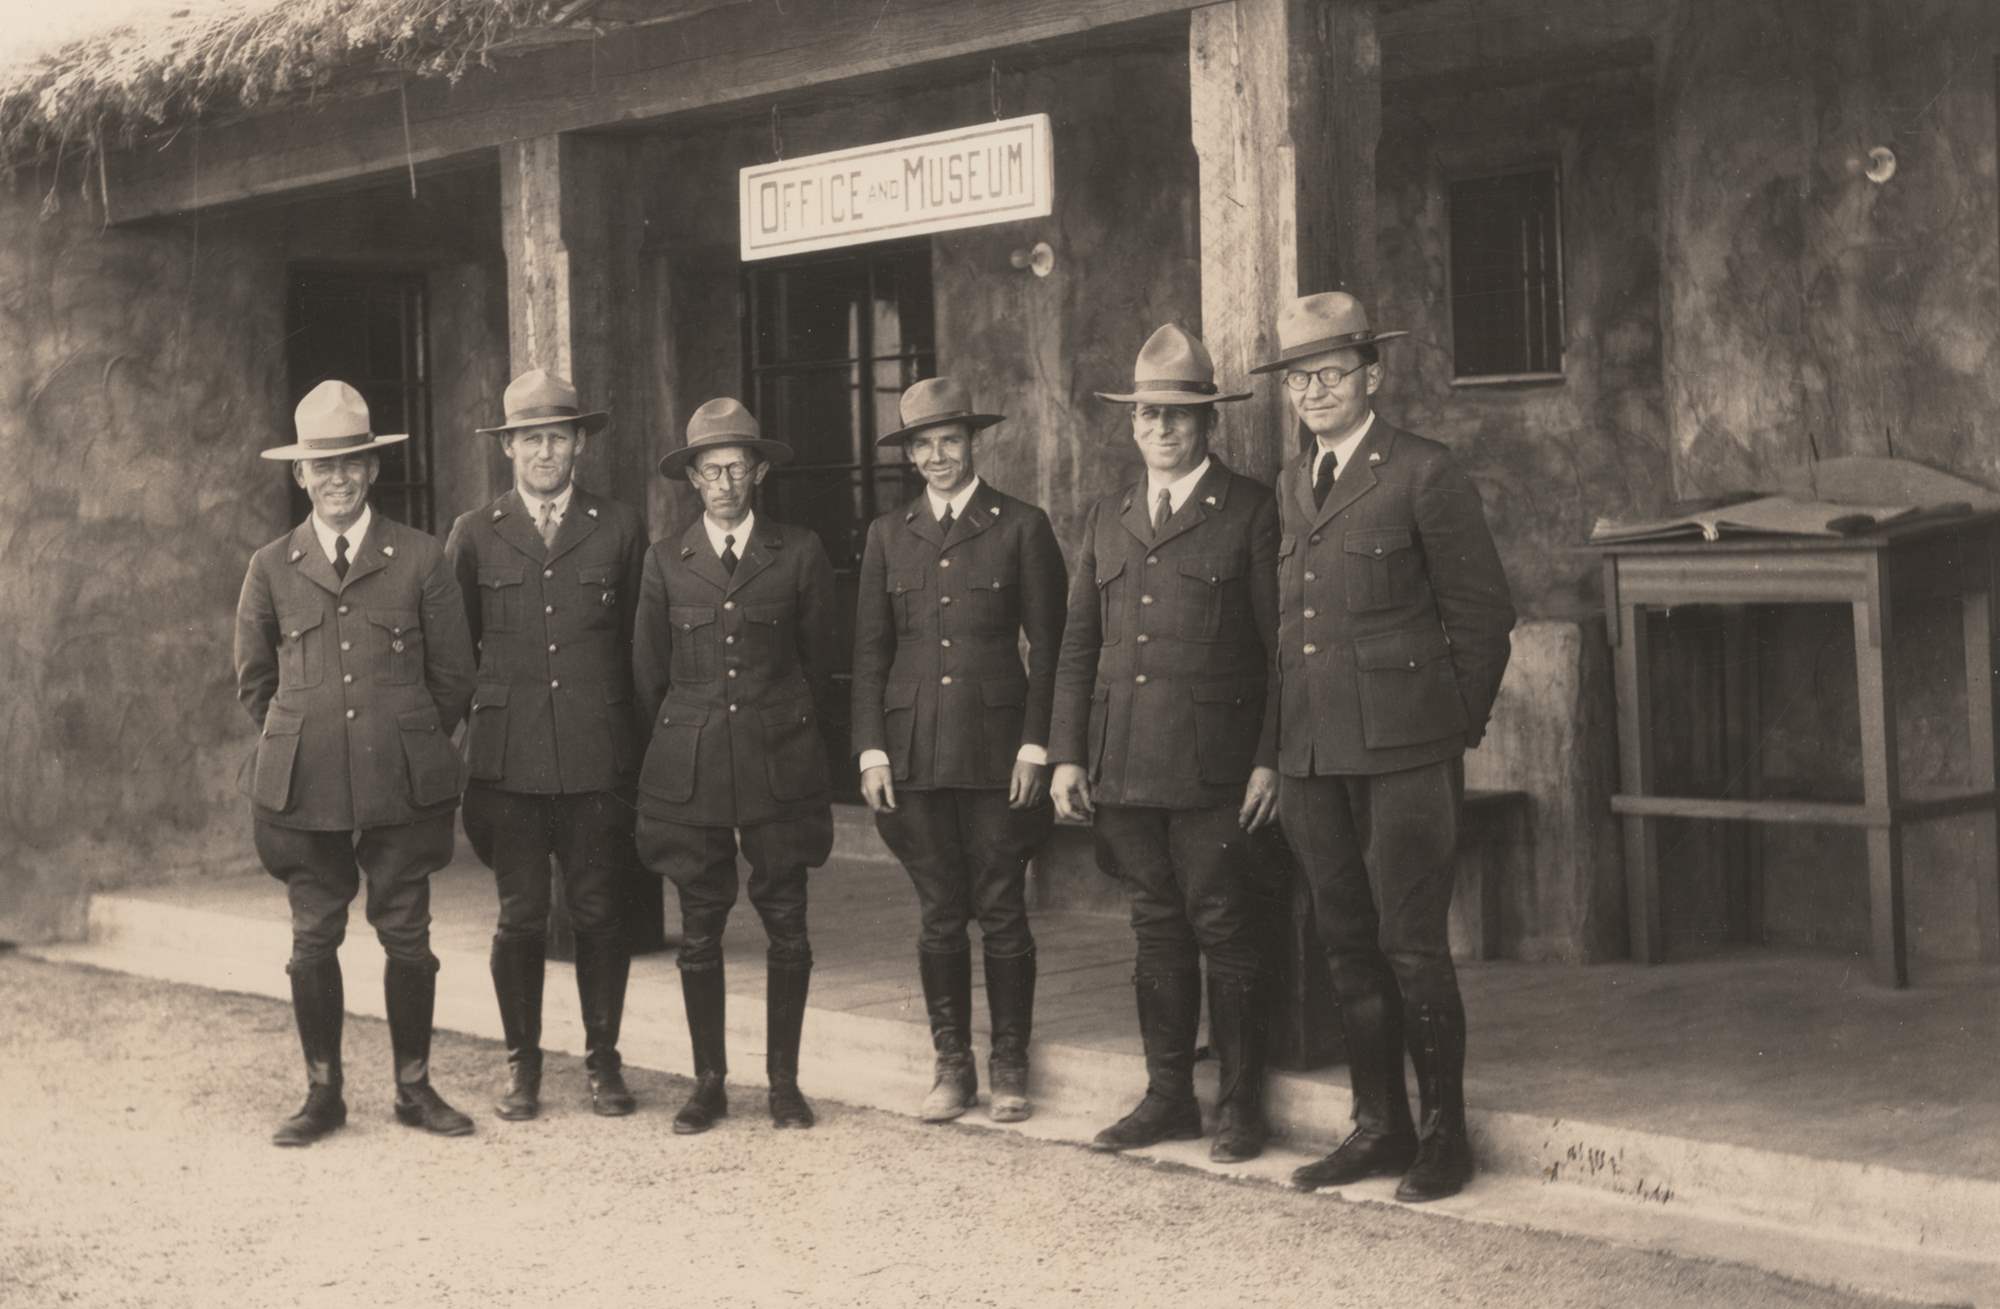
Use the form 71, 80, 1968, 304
1048, 456, 1278, 809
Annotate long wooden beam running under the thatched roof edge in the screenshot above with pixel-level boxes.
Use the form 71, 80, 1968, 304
108, 0, 1196, 222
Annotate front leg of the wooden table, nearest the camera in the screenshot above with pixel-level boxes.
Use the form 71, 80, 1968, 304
1854, 588, 1910, 987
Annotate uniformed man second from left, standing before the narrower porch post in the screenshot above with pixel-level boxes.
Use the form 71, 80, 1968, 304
444, 368, 646, 1119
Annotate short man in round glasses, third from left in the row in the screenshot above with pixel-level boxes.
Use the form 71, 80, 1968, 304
632, 398, 834, 1135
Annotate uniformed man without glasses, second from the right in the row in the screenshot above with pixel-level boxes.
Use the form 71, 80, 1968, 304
1048, 324, 1278, 1163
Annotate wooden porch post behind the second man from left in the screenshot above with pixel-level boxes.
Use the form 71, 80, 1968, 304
500, 134, 664, 959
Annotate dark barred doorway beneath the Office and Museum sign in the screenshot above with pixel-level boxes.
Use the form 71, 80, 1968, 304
744, 240, 938, 801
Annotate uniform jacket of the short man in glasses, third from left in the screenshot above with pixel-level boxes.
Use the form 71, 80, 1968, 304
632, 514, 834, 827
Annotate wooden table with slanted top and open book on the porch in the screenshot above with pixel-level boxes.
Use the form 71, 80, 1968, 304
1594, 512, 2000, 987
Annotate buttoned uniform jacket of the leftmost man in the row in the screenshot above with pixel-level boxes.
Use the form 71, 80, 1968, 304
236, 512, 472, 831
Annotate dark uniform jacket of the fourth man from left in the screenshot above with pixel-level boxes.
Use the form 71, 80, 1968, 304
852, 480, 1068, 791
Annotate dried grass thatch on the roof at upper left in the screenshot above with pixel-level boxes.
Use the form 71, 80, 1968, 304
0, 0, 576, 164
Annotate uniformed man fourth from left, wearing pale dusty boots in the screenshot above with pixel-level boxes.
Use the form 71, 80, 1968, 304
854, 378, 1068, 1123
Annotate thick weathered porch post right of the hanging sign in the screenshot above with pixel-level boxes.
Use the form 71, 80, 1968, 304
1188, 0, 1382, 480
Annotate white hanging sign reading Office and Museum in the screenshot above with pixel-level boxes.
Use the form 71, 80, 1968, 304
738, 114, 1056, 260
